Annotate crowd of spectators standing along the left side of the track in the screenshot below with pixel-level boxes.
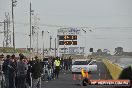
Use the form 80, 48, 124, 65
0, 54, 72, 88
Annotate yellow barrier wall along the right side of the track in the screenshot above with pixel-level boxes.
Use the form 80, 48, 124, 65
103, 59, 122, 79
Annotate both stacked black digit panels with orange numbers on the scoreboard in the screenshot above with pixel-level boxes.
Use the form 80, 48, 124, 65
58, 35, 77, 45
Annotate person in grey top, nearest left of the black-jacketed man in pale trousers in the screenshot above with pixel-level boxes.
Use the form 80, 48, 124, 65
17, 55, 28, 88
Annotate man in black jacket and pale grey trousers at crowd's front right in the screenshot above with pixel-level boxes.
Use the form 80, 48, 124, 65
31, 56, 43, 88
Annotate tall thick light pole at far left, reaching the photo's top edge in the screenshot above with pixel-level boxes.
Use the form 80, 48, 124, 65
12, 0, 17, 53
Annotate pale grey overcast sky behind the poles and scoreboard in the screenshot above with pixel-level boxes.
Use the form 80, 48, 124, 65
0, 0, 132, 51
